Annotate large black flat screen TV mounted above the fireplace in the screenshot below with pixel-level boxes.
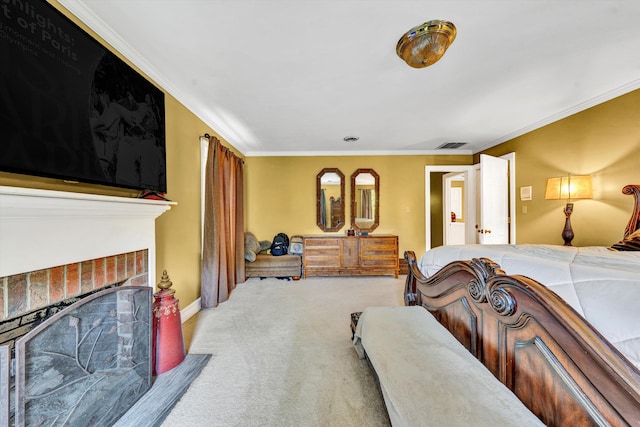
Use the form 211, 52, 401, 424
0, 0, 167, 193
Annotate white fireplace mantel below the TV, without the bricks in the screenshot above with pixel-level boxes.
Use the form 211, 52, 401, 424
0, 186, 175, 285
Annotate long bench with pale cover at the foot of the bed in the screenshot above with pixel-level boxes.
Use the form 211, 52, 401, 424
354, 306, 543, 426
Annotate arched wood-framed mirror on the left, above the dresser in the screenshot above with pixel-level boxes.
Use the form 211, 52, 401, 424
316, 168, 344, 231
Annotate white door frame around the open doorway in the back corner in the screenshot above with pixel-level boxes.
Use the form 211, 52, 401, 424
424, 152, 516, 251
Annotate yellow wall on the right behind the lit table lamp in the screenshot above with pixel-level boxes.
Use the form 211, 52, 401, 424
485, 90, 640, 246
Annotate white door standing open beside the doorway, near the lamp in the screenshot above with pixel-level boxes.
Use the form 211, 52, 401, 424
476, 154, 509, 245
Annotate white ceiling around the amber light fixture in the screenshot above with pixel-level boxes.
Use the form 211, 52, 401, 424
59, 0, 640, 156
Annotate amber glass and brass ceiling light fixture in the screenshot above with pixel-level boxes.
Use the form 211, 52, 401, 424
396, 20, 456, 68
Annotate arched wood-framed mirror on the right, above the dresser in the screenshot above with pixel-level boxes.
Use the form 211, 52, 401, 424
351, 169, 380, 232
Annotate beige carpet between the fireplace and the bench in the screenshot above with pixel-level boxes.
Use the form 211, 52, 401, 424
163, 276, 404, 427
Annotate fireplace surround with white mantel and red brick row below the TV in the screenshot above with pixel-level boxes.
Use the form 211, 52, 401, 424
0, 186, 174, 328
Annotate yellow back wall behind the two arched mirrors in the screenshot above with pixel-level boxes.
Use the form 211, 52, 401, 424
245, 156, 471, 254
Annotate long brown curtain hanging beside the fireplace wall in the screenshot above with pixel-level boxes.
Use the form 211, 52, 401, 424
201, 137, 245, 308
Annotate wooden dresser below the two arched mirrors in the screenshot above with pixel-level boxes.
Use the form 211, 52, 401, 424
302, 234, 400, 278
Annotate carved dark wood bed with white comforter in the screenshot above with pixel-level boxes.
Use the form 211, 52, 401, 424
357, 185, 640, 426
